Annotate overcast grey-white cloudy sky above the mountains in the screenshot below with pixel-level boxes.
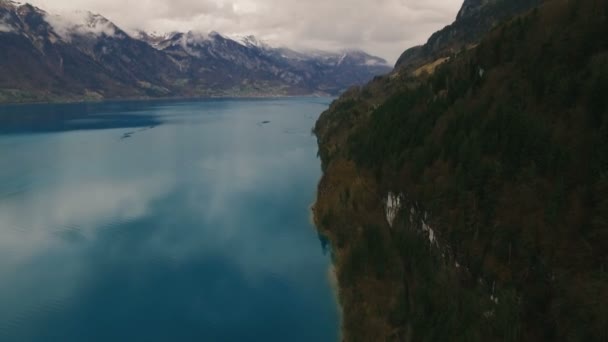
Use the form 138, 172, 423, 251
23, 0, 463, 63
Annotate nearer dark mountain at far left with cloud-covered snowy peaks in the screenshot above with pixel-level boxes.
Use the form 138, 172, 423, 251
0, 2, 178, 102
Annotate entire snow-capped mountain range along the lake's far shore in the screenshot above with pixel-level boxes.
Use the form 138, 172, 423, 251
0, 0, 390, 102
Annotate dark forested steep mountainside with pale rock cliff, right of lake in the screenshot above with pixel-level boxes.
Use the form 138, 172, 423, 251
314, 0, 608, 341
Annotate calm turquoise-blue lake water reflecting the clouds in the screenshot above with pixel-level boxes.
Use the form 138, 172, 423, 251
0, 98, 339, 341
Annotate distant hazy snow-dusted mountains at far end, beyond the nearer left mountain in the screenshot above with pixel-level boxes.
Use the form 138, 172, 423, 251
137, 32, 390, 94
